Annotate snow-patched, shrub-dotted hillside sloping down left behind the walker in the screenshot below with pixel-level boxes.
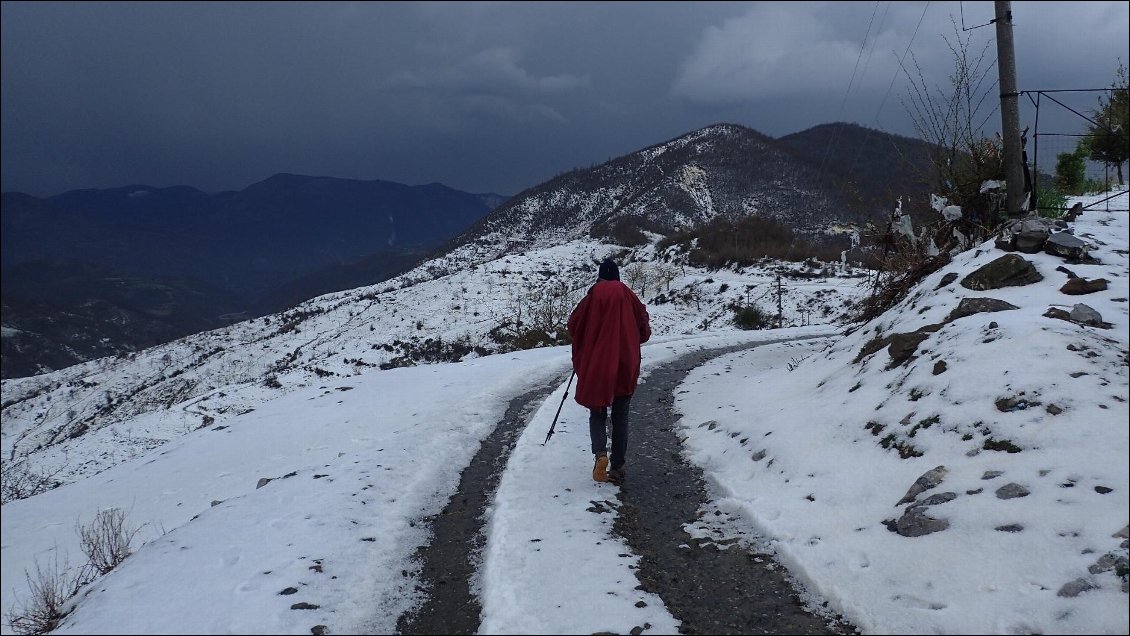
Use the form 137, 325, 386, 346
2, 239, 864, 483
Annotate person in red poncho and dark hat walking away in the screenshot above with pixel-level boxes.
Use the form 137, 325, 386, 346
567, 259, 651, 485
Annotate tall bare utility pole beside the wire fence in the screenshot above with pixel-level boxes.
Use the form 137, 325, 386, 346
993, 0, 1027, 217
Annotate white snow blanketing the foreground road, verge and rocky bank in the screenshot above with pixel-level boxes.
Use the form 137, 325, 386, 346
0, 194, 1130, 634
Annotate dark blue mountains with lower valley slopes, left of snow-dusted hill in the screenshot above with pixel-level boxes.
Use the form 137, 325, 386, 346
0, 174, 505, 377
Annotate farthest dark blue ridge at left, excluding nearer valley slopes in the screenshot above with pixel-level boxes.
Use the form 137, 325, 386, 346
0, 174, 496, 297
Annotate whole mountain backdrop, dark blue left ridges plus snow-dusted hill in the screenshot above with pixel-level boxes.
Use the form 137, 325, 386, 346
0, 123, 929, 377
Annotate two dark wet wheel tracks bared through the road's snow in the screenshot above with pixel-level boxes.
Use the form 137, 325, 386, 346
397, 345, 855, 634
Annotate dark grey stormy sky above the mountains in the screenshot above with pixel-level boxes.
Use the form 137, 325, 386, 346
0, 1, 1130, 197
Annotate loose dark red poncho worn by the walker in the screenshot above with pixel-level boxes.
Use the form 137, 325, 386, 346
568, 280, 651, 409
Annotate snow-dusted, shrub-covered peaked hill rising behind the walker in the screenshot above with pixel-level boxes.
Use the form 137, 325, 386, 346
451, 123, 877, 256
